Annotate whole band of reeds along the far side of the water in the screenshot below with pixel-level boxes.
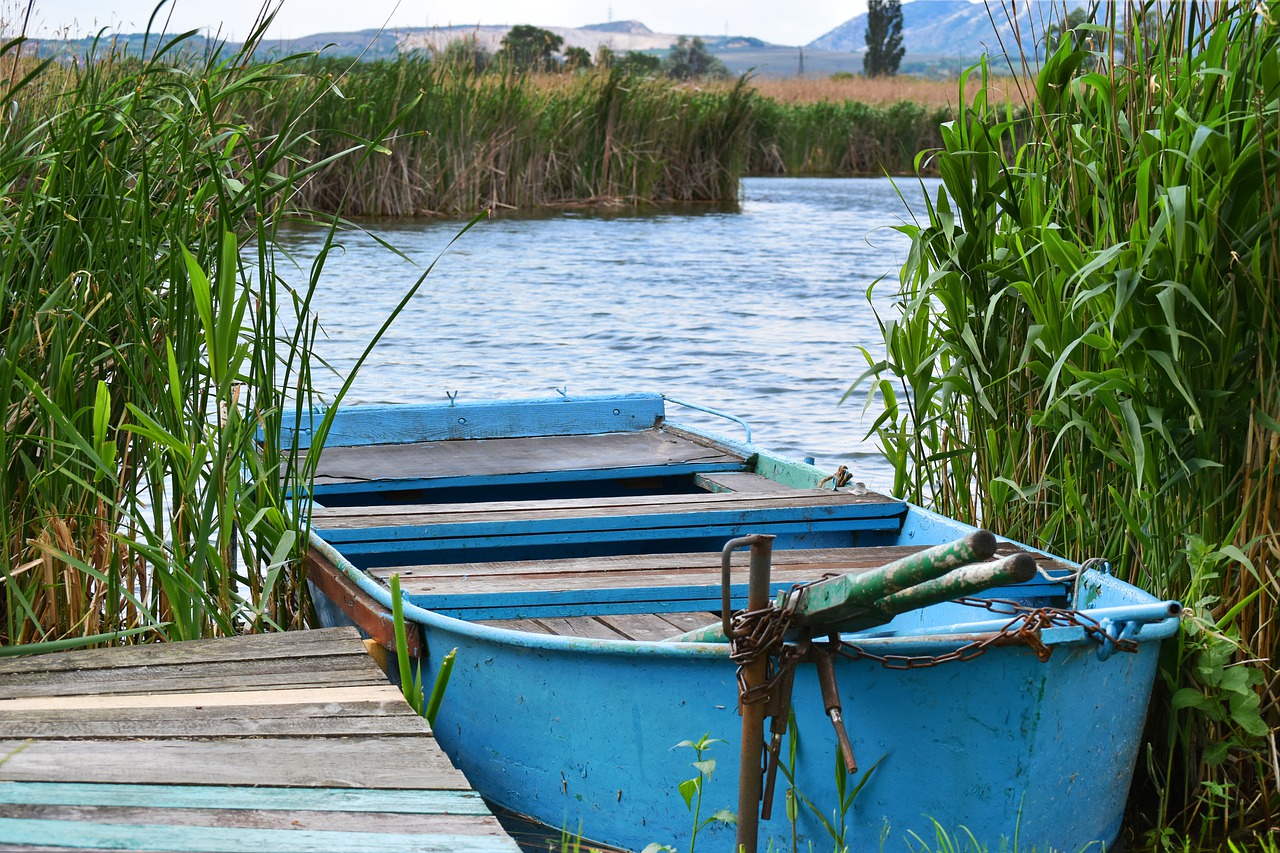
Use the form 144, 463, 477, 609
264, 55, 951, 216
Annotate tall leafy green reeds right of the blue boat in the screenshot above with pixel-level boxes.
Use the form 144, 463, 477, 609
859, 3, 1280, 845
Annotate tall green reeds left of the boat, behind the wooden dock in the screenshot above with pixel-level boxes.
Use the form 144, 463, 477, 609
0, 18, 399, 649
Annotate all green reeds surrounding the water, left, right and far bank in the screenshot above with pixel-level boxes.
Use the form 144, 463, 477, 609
0, 0, 1280, 850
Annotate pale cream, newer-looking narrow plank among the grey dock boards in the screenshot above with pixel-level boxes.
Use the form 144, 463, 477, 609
0, 680, 412, 713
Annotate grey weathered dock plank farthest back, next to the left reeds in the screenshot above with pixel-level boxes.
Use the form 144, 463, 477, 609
0, 628, 361, 676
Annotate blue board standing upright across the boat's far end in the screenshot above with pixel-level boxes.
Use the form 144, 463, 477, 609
282, 394, 664, 447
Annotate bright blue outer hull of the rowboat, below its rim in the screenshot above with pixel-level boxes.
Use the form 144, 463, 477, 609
309, 540, 1172, 850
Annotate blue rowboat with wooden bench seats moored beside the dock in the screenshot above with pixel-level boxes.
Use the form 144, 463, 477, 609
296, 394, 1179, 850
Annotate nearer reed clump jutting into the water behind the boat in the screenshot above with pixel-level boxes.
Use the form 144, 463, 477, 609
275, 55, 754, 215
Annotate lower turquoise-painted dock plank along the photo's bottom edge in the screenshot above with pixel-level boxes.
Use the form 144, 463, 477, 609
0, 817, 520, 853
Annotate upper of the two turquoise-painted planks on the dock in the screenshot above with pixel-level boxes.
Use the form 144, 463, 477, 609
0, 781, 489, 815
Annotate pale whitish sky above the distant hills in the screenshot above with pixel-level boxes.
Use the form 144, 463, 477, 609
20, 0, 885, 45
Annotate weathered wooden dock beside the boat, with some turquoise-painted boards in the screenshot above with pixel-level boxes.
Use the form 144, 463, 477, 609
0, 629, 518, 853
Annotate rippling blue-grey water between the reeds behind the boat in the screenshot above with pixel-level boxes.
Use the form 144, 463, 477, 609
287, 178, 936, 488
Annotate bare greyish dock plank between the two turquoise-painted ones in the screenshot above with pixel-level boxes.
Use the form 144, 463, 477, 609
4, 804, 504, 829
